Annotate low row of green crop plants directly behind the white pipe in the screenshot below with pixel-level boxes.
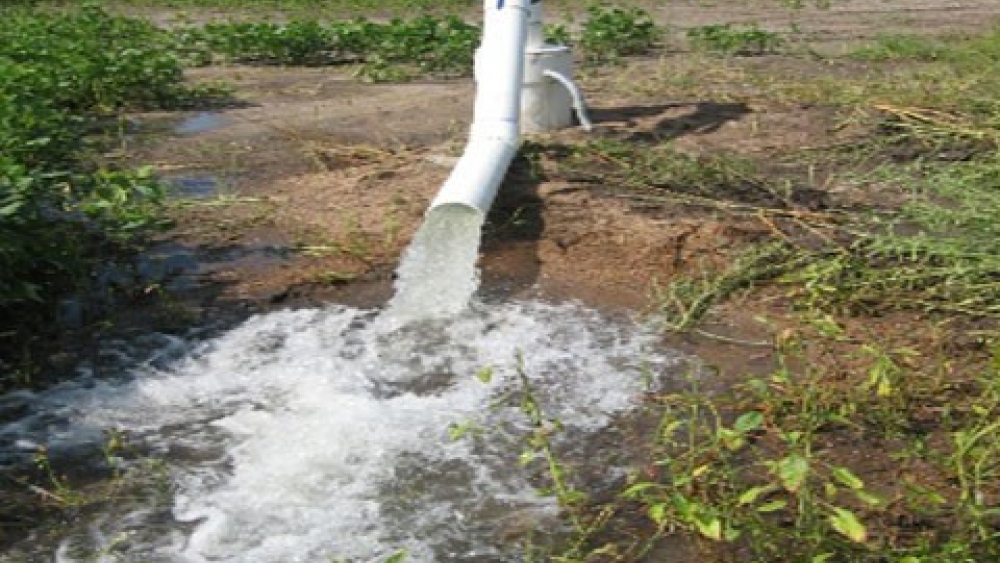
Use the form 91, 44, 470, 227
173, 7, 660, 77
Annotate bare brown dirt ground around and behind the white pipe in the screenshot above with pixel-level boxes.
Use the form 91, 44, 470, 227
121, 0, 1000, 374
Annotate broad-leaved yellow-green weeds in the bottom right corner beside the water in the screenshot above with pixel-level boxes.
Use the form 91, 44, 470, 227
600, 333, 998, 563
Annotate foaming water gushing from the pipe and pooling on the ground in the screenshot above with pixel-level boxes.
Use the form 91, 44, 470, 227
0, 205, 680, 563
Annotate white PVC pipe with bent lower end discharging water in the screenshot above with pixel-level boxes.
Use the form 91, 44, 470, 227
430, 0, 541, 217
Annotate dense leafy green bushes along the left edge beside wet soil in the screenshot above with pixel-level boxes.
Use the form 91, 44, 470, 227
0, 7, 208, 306
